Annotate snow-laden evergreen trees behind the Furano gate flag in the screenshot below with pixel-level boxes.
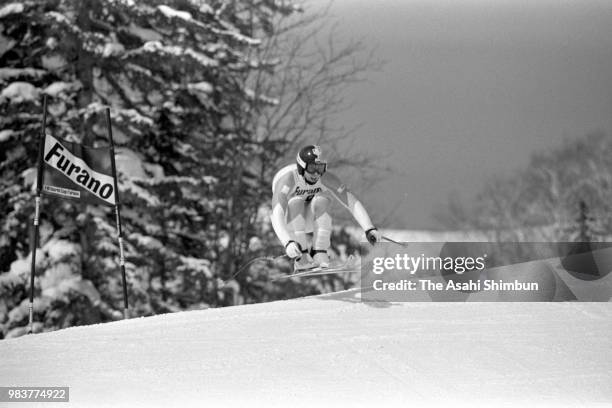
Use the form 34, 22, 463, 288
0, 0, 294, 336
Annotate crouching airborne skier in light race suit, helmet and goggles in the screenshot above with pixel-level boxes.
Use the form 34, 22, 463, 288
271, 145, 382, 271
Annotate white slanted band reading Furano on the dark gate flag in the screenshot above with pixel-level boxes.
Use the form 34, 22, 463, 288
43, 135, 115, 204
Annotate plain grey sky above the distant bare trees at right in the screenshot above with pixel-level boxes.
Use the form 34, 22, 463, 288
315, 0, 612, 228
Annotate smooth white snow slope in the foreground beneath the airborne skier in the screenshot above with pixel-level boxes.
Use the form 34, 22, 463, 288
0, 291, 612, 407
